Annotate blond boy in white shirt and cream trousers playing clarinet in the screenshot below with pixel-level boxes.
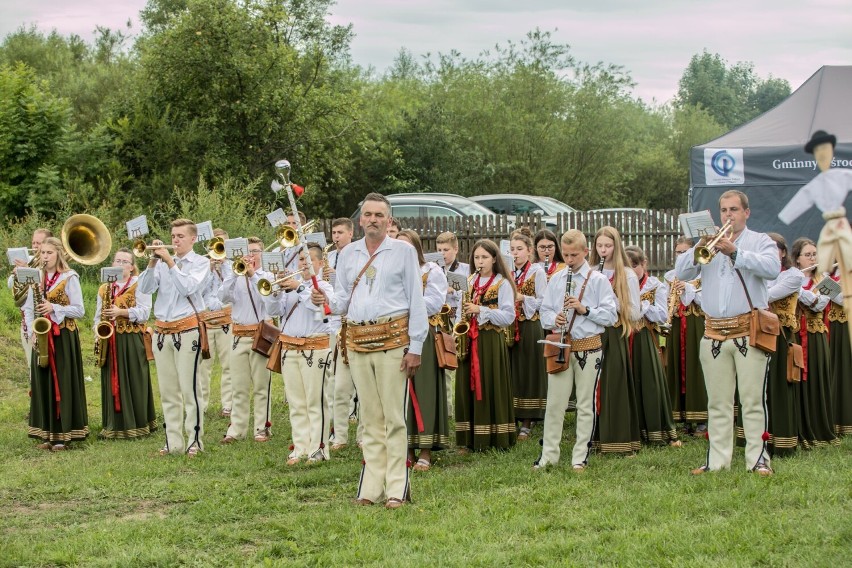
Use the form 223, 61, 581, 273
533, 229, 617, 471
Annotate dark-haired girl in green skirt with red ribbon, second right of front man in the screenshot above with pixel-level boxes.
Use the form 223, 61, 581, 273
456, 239, 517, 451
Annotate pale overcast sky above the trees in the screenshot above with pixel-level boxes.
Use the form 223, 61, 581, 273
0, 0, 852, 102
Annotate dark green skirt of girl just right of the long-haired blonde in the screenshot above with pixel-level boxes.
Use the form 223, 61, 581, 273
631, 327, 677, 444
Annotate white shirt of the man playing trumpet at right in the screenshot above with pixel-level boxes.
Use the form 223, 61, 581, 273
676, 229, 781, 318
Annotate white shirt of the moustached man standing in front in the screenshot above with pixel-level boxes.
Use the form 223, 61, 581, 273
329, 238, 429, 355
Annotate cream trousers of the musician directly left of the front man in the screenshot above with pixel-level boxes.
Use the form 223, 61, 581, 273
281, 349, 331, 459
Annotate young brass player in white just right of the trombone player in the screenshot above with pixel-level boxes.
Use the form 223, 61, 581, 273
218, 237, 275, 444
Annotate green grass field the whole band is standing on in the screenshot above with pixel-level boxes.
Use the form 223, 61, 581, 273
0, 300, 852, 567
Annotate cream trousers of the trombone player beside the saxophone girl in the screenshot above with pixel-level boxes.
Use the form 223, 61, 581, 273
154, 329, 204, 454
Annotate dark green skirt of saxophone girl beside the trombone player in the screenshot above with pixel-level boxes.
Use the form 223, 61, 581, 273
100, 333, 157, 439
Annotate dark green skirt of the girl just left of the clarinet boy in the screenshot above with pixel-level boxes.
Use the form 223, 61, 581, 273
509, 320, 547, 420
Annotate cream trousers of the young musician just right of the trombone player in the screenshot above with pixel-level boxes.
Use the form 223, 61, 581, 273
223, 334, 272, 440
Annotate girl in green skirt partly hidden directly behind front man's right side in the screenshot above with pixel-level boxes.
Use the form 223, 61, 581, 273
397, 229, 450, 471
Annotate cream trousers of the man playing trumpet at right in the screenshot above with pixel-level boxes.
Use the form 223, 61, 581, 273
699, 337, 769, 471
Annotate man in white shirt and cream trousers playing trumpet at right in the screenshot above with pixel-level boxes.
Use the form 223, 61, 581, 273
675, 190, 781, 476
